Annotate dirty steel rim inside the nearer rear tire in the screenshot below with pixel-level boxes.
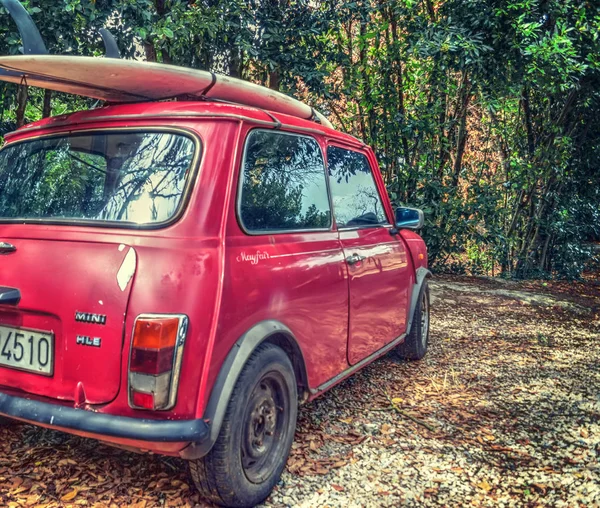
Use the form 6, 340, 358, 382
241, 372, 290, 484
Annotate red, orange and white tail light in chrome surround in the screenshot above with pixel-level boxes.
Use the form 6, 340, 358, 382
129, 314, 188, 411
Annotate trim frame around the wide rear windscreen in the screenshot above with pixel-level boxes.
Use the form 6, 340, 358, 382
0, 125, 204, 231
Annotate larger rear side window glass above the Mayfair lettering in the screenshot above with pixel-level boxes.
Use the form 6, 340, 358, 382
239, 130, 331, 232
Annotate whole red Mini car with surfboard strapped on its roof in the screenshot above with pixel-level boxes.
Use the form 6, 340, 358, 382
0, 2, 430, 506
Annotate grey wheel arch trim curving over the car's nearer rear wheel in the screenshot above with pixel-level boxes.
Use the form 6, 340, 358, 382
181, 320, 309, 459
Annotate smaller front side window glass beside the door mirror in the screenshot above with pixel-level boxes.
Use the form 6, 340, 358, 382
327, 146, 388, 228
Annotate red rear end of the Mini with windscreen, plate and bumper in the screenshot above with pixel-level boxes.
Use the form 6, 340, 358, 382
0, 105, 236, 454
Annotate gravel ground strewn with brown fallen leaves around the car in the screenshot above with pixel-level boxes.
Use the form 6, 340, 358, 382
0, 278, 600, 506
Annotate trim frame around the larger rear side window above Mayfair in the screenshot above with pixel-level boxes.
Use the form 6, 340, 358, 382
235, 127, 335, 236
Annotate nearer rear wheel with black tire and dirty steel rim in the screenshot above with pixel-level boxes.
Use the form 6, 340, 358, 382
189, 344, 298, 507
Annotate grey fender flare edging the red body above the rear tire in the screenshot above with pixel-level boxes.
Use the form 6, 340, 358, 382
180, 320, 304, 460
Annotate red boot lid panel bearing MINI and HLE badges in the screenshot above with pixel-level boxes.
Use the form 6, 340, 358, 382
0, 235, 136, 404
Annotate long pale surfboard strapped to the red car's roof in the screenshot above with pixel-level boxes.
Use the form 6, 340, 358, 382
0, 55, 332, 128
